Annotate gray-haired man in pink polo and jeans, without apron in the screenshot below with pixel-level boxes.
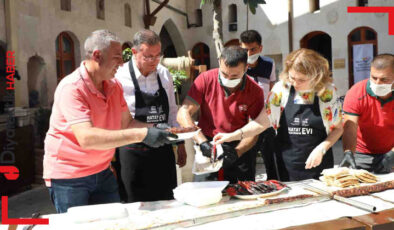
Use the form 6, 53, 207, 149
43, 30, 177, 213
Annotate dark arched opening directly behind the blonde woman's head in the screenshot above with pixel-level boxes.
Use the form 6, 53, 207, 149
300, 31, 332, 69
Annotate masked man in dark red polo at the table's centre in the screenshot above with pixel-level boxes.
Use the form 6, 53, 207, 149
178, 46, 264, 183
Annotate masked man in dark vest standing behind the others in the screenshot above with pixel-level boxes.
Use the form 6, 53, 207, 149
240, 30, 279, 179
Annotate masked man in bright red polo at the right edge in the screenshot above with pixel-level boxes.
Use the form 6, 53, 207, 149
340, 54, 394, 173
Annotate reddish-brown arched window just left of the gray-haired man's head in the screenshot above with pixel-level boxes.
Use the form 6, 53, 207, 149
56, 32, 75, 82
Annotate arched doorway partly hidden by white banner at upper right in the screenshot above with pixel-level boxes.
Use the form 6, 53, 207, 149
347, 26, 378, 88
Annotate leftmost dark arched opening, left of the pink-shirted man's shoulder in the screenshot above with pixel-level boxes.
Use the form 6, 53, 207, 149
27, 56, 48, 107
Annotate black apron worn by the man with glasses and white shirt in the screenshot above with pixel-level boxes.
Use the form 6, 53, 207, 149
119, 61, 176, 202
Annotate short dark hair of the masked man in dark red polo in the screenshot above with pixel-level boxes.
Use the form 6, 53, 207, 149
220, 46, 248, 67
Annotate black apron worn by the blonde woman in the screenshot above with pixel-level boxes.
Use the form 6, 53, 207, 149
276, 87, 334, 181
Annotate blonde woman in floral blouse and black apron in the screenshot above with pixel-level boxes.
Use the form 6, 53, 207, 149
214, 49, 343, 181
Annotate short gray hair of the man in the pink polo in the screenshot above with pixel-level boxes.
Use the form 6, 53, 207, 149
84, 30, 121, 59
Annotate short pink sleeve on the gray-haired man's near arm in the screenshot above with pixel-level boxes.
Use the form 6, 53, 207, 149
59, 84, 91, 125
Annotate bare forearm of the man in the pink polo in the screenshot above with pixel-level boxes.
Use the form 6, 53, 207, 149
80, 127, 148, 150
